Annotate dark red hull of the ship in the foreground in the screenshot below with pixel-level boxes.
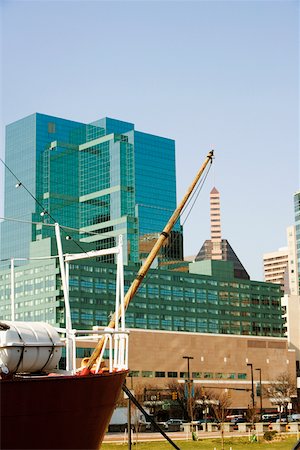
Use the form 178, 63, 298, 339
0, 371, 127, 450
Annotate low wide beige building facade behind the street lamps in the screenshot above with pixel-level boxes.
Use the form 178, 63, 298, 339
129, 329, 296, 409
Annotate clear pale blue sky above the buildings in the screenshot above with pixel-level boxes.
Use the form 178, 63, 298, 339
1, 0, 299, 280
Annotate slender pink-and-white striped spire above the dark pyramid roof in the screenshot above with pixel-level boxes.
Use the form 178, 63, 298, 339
210, 187, 222, 259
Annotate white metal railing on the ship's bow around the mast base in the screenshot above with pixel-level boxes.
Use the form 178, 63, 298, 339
56, 327, 129, 374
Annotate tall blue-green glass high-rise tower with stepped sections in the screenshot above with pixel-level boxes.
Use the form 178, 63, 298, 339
1, 114, 183, 263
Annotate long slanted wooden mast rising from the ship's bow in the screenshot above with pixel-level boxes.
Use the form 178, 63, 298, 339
81, 150, 214, 374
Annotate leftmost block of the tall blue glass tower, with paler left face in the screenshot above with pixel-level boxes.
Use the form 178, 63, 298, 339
1, 114, 85, 259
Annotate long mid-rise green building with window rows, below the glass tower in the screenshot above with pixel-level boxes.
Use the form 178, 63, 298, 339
0, 246, 284, 337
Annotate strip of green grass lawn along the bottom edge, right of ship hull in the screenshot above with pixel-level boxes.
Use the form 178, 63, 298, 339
101, 436, 297, 450
